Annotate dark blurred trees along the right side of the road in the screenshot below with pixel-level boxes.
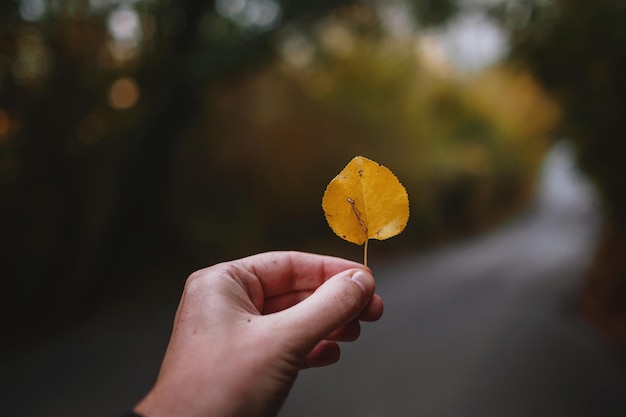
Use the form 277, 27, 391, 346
504, 0, 626, 343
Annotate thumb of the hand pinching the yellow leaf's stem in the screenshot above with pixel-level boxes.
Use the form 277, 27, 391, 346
270, 268, 376, 352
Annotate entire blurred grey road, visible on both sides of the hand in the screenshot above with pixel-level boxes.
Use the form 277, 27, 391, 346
0, 144, 626, 417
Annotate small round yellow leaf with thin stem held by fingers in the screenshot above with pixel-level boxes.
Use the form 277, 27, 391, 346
322, 156, 409, 265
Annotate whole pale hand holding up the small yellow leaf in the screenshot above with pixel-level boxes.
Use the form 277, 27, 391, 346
135, 252, 383, 417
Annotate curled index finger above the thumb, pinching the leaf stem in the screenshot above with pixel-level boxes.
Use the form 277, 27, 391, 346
241, 252, 365, 298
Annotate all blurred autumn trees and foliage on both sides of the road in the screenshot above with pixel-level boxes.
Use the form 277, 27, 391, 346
0, 0, 626, 412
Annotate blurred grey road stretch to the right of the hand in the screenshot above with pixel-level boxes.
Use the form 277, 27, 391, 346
281, 143, 626, 417
